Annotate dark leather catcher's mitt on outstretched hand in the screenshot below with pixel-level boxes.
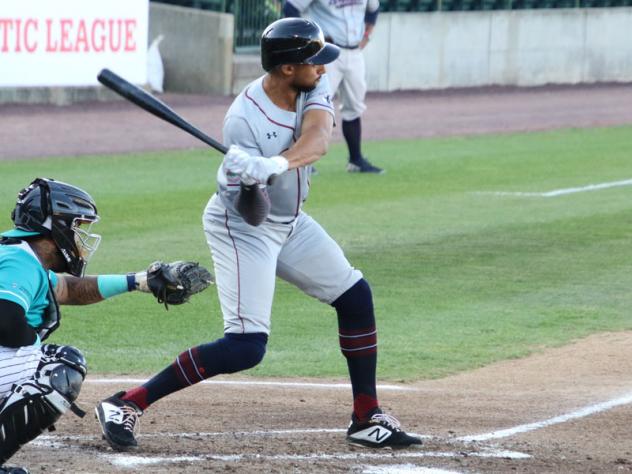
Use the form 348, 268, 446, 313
147, 260, 213, 309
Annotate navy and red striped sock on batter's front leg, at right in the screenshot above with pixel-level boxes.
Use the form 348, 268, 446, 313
332, 279, 378, 420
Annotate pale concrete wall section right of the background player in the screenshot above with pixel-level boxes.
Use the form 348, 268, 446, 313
365, 8, 632, 91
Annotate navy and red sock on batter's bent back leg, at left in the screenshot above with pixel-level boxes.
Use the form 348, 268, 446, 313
121, 333, 268, 410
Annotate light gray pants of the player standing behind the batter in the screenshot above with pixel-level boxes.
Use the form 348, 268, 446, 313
325, 48, 366, 121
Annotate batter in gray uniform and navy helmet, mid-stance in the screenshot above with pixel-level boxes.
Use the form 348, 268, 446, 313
97, 18, 421, 450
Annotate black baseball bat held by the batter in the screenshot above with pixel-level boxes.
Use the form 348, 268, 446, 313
97, 69, 276, 184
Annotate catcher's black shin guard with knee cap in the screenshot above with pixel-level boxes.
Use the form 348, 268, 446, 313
0, 344, 87, 464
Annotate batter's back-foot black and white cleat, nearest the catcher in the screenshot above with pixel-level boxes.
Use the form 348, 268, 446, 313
94, 392, 143, 451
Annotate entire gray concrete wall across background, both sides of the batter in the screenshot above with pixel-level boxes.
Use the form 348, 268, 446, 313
0, 6, 632, 104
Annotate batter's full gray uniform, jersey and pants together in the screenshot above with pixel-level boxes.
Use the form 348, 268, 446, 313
203, 75, 362, 334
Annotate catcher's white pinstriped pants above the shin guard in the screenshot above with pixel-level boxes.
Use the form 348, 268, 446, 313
0, 344, 42, 402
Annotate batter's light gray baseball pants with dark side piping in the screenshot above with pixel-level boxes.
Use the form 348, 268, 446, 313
203, 195, 362, 334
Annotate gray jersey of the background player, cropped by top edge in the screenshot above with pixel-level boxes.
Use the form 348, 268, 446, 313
288, 0, 380, 47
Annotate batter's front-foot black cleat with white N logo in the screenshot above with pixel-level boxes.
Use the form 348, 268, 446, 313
347, 408, 421, 449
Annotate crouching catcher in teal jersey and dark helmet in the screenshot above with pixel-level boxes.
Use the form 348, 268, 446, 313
0, 178, 210, 474
